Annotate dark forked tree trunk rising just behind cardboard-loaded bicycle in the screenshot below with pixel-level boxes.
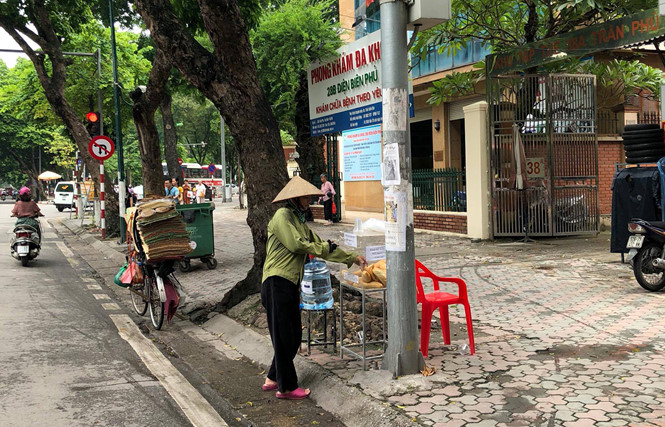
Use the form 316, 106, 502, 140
130, 49, 171, 195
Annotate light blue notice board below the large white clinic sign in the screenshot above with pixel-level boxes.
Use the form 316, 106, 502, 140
342, 125, 381, 181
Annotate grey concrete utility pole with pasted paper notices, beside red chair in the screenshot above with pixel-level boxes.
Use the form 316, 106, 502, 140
380, 0, 424, 377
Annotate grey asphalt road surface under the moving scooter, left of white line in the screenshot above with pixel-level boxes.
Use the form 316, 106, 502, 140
0, 201, 208, 427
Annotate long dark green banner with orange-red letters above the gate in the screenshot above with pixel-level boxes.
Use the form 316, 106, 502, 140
485, 8, 665, 76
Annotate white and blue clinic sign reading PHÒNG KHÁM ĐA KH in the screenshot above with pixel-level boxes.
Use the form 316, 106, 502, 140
307, 31, 414, 136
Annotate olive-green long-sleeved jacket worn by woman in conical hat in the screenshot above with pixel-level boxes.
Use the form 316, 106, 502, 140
262, 208, 356, 284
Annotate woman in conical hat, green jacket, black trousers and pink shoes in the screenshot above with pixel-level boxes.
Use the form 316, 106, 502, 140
261, 176, 367, 399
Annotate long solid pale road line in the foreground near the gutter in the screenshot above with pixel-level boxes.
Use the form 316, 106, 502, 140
109, 314, 228, 427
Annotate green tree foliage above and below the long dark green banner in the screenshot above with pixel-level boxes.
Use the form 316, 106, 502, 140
420, 0, 660, 104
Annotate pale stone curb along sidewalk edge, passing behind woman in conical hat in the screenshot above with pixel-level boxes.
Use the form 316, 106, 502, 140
58, 220, 416, 427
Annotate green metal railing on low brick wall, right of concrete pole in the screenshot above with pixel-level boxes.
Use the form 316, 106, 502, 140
413, 168, 466, 212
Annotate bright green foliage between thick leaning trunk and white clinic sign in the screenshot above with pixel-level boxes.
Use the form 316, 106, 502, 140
250, 0, 341, 134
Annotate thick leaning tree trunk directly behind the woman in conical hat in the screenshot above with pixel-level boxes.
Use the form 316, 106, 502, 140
135, 0, 287, 310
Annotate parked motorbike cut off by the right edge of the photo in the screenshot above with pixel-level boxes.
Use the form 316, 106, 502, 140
626, 218, 665, 292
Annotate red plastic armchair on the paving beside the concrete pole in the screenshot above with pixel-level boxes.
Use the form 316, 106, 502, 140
416, 260, 476, 357
